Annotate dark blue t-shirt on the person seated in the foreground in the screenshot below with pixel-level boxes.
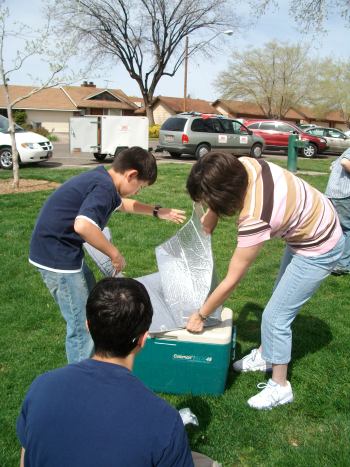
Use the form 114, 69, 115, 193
17, 359, 193, 467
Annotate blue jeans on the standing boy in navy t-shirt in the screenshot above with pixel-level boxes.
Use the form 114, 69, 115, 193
38, 263, 96, 363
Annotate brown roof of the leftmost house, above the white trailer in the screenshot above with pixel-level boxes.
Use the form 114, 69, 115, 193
0, 85, 137, 111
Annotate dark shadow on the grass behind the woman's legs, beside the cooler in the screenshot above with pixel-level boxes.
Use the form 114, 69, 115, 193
226, 302, 333, 388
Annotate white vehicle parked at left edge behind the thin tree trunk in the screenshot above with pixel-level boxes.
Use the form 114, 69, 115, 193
0, 115, 52, 170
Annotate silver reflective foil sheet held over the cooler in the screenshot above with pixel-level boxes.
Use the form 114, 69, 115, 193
84, 203, 222, 333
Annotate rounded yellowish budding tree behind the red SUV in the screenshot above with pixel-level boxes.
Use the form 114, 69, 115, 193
216, 42, 312, 118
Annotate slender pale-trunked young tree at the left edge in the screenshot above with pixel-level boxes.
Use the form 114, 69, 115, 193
0, 0, 90, 188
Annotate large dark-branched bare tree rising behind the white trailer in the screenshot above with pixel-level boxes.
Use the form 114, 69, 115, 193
50, 0, 237, 124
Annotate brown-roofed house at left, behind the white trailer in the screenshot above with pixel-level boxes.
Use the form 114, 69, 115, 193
0, 81, 138, 133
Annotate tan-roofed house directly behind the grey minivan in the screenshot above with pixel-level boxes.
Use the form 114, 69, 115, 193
135, 96, 220, 125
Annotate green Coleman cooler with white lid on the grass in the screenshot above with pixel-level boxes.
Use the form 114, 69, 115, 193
133, 308, 235, 395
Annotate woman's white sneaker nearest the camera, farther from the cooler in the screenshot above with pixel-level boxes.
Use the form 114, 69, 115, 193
248, 379, 294, 410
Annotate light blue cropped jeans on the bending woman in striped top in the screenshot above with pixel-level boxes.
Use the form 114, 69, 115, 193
261, 237, 344, 364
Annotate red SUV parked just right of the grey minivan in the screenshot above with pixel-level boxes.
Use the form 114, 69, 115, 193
244, 120, 327, 157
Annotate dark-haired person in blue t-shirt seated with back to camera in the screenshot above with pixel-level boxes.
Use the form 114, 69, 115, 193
17, 278, 193, 467
